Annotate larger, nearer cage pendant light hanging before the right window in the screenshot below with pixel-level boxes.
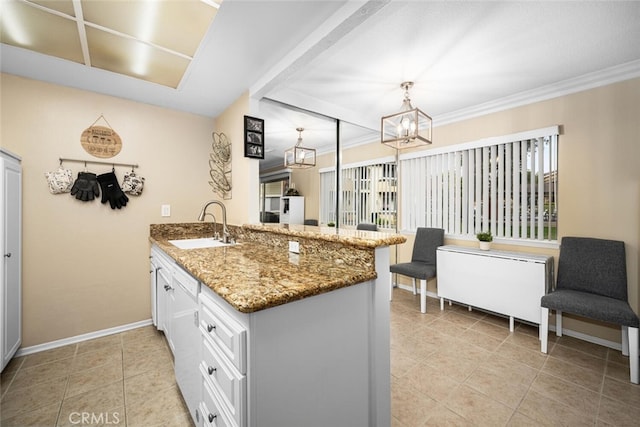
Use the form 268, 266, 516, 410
381, 82, 432, 150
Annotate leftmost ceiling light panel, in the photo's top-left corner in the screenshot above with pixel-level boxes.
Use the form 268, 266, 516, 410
0, 1, 84, 64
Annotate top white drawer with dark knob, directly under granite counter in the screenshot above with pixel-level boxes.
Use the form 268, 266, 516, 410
200, 287, 247, 374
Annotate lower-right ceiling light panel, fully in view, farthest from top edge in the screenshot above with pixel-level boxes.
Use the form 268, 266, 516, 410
87, 27, 189, 88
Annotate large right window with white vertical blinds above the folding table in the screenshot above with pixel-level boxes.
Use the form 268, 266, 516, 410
400, 126, 558, 241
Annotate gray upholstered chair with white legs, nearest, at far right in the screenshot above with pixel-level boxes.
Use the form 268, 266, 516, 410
540, 237, 640, 384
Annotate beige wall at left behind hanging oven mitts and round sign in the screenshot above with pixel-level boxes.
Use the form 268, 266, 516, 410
0, 74, 257, 346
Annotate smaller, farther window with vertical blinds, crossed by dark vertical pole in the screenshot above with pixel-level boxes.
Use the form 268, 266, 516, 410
320, 159, 397, 228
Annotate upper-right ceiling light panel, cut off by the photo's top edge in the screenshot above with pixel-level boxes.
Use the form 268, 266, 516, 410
82, 0, 217, 57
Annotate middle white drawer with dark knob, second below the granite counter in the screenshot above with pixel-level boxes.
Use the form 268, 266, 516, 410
200, 339, 247, 425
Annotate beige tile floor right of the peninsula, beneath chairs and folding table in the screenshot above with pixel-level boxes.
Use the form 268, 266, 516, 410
391, 289, 640, 427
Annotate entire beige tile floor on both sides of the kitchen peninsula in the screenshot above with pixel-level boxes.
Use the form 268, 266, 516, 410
0, 289, 640, 427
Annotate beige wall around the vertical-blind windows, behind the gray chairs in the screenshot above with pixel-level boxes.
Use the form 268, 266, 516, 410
295, 79, 640, 341
